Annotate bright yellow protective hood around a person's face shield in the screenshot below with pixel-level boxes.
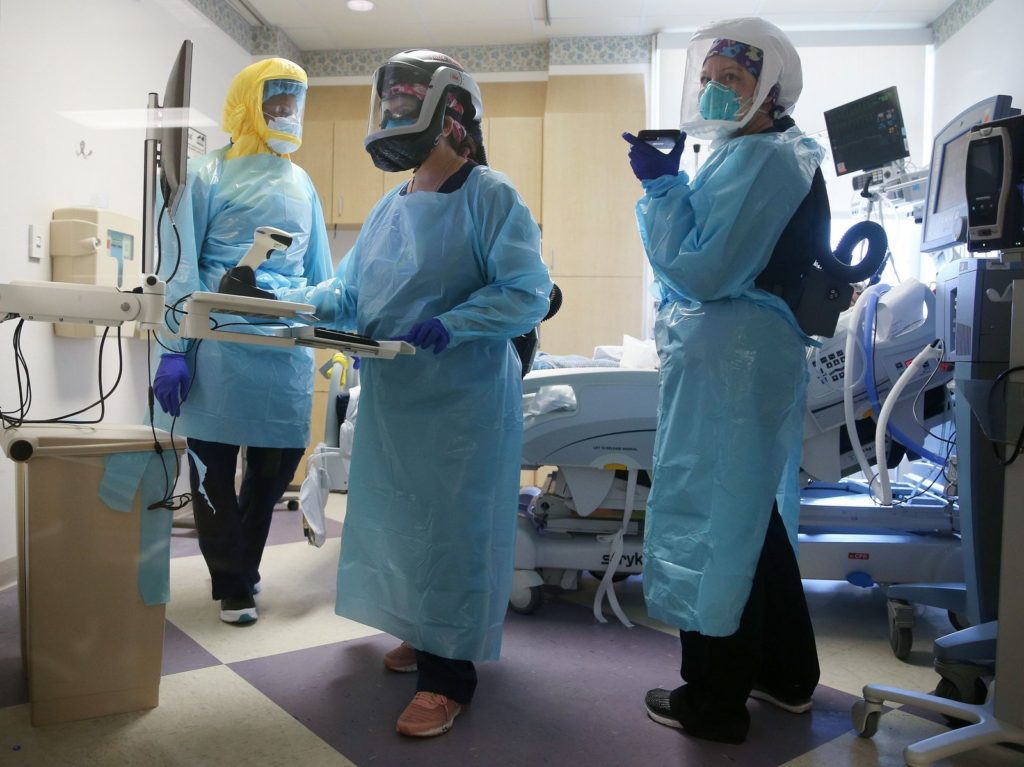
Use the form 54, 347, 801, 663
220, 58, 306, 160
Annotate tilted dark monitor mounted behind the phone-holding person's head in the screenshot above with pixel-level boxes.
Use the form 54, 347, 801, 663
825, 85, 910, 176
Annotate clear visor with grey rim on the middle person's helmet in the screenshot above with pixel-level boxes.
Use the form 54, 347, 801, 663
365, 61, 483, 144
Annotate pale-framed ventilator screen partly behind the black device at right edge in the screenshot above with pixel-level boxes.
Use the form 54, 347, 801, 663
921, 96, 1020, 253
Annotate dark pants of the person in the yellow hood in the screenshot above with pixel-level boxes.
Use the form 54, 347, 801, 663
188, 437, 305, 599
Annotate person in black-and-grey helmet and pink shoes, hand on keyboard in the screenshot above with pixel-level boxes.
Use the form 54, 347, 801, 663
325, 50, 551, 737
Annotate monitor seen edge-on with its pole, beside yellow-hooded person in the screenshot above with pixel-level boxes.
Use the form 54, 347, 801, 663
142, 40, 193, 274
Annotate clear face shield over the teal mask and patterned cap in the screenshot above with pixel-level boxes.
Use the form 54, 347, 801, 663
679, 36, 779, 140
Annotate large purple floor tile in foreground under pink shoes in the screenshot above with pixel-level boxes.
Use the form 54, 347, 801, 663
231, 599, 856, 767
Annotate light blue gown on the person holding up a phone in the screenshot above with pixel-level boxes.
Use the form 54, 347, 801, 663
637, 128, 824, 636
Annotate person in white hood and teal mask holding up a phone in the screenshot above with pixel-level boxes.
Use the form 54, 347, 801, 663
624, 18, 829, 742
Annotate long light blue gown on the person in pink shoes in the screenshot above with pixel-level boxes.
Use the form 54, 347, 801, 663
336, 166, 551, 661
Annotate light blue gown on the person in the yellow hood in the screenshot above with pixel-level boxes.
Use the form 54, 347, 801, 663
154, 146, 332, 448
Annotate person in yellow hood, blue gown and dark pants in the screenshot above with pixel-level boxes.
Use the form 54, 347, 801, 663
153, 58, 333, 624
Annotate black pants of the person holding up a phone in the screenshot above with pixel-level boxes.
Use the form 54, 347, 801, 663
670, 507, 820, 726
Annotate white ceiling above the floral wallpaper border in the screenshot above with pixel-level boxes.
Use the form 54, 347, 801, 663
229, 0, 953, 50
